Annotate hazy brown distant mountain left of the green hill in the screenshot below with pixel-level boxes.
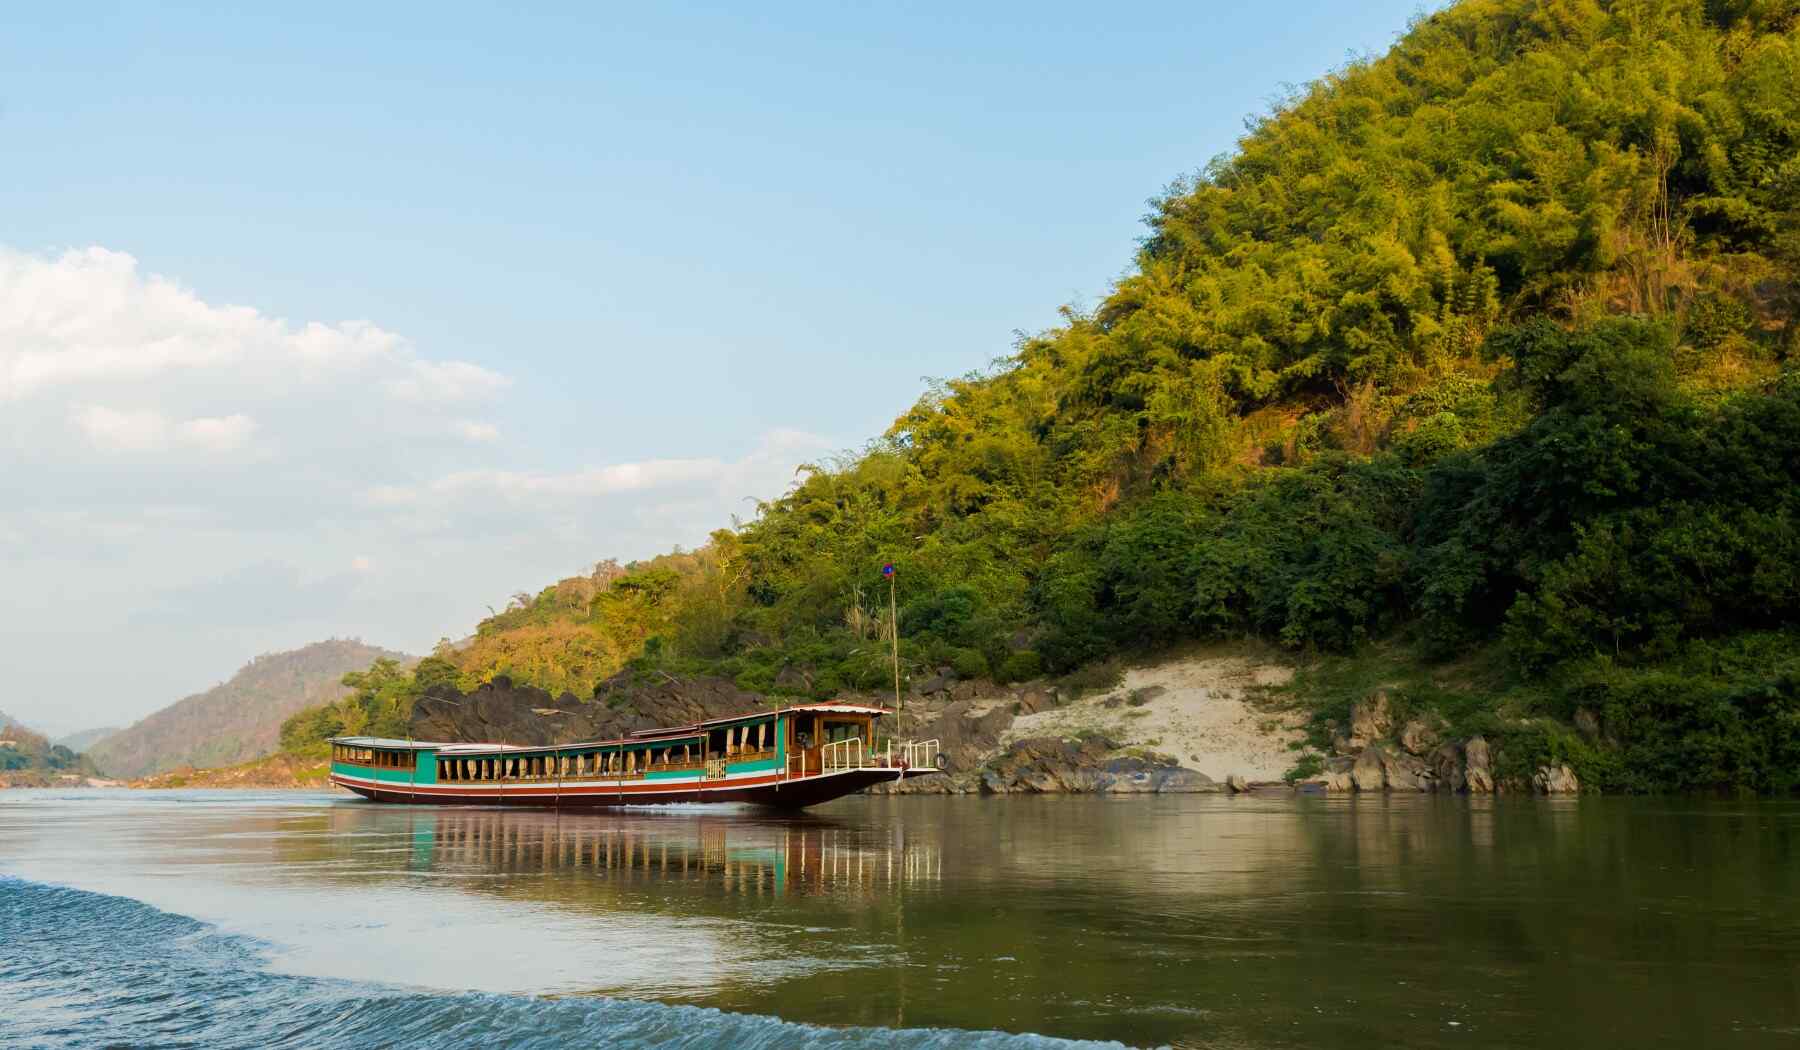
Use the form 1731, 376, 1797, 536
88, 638, 414, 776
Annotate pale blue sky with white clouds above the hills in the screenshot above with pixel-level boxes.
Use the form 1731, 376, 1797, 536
0, 0, 1420, 729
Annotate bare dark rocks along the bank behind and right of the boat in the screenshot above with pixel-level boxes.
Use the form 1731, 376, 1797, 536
410, 668, 1580, 794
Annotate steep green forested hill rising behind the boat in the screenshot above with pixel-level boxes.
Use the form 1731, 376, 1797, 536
298, 0, 1800, 791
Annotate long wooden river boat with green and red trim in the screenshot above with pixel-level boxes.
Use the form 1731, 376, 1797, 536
331, 702, 941, 809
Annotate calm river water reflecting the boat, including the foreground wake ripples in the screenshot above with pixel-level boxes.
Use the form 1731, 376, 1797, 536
0, 791, 1800, 1050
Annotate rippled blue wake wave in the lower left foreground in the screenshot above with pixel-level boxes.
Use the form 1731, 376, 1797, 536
0, 877, 1118, 1050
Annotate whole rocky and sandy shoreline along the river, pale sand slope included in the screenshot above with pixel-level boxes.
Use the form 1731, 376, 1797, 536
98, 657, 1580, 794
